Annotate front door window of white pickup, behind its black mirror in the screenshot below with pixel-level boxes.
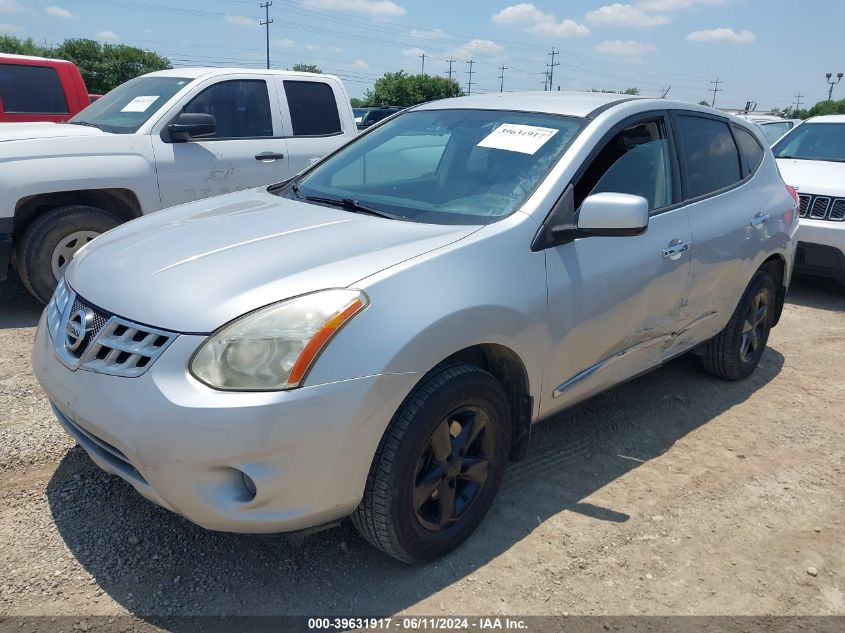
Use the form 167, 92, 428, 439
182, 79, 273, 140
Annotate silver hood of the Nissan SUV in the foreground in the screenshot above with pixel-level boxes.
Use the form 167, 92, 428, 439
66, 189, 480, 333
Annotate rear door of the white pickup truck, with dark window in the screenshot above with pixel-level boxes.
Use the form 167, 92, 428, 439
276, 76, 356, 174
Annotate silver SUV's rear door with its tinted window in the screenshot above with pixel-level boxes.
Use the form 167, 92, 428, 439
673, 111, 770, 344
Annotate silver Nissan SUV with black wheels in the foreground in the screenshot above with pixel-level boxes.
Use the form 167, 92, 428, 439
33, 93, 798, 562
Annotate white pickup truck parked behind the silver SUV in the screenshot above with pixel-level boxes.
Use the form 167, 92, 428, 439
0, 68, 357, 302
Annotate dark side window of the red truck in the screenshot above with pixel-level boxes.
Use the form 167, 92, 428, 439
0, 64, 68, 114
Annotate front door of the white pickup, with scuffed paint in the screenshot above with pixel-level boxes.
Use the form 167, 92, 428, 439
152, 78, 288, 207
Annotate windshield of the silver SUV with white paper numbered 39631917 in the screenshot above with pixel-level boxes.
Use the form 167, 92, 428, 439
282, 110, 585, 224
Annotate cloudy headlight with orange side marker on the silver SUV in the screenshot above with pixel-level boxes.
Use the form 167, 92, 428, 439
191, 290, 369, 391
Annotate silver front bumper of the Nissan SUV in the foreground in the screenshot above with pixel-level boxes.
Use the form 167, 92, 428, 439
33, 316, 418, 532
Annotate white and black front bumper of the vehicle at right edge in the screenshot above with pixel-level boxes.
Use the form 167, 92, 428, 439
795, 218, 845, 283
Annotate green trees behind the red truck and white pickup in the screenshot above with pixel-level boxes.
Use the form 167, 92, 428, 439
0, 36, 171, 94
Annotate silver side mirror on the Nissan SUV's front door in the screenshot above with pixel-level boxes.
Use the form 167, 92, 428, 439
577, 193, 648, 236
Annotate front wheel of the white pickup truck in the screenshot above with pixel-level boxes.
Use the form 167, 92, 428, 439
17, 204, 120, 303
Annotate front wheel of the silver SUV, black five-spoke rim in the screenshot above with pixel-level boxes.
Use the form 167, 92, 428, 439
351, 364, 511, 563
